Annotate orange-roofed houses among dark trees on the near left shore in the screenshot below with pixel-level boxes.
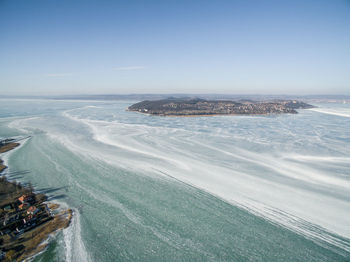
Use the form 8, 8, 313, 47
0, 194, 51, 237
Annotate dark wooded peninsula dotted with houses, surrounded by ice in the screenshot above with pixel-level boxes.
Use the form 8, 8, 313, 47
128, 98, 314, 116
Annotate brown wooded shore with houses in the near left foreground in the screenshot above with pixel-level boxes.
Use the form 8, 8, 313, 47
0, 139, 73, 261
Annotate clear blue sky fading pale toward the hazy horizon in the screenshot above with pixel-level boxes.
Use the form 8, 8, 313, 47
0, 0, 350, 95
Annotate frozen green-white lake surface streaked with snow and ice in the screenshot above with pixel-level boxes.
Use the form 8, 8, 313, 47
0, 100, 350, 261
